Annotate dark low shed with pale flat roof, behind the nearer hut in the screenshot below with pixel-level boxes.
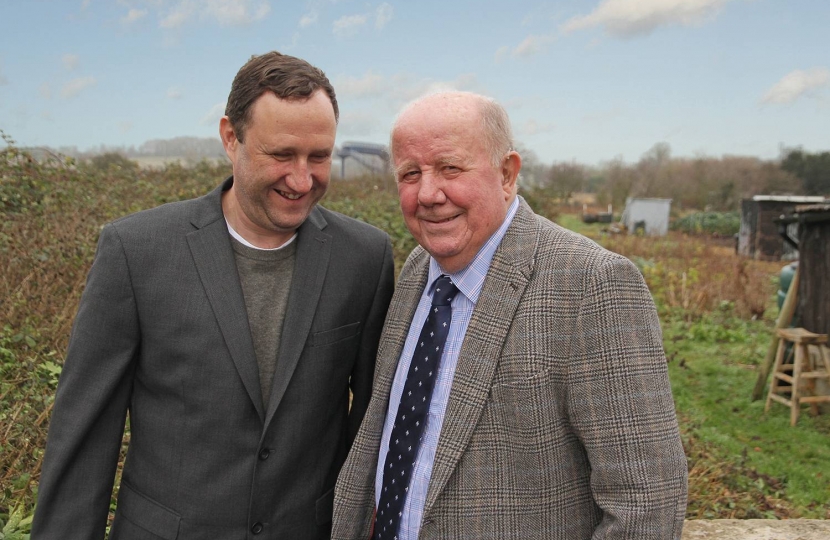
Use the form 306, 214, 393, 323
738, 195, 825, 261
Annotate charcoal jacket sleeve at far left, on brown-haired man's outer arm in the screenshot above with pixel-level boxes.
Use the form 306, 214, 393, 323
32, 224, 140, 540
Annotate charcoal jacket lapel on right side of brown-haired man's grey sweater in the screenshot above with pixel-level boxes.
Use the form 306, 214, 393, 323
265, 208, 331, 427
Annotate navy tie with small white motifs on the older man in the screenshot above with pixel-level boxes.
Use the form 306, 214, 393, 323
373, 275, 458, 540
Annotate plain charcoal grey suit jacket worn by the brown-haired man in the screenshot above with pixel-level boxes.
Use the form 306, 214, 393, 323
32, 178, 394, 540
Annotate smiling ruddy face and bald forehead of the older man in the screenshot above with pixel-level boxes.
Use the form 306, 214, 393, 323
392, 95, 515, 272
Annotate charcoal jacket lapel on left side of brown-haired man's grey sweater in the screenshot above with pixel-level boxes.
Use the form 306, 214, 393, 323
187, 179, 265, 420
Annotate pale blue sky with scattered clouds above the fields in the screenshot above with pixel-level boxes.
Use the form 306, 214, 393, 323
0, 0, 830, 164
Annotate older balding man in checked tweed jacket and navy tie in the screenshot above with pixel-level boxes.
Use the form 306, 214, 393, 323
332, 93, 687, 540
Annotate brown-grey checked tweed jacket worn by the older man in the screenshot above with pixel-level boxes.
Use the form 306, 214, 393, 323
332, 201, 687, 540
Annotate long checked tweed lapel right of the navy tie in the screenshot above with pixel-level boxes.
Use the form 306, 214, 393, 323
424, 199, 539, 516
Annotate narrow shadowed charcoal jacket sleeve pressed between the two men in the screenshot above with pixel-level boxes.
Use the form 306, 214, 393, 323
348, 236, 395, 448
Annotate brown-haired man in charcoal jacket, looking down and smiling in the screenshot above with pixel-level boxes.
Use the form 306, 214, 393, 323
32, 52, 394, 540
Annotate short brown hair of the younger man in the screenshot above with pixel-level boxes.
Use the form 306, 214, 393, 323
225, 51, 340, 142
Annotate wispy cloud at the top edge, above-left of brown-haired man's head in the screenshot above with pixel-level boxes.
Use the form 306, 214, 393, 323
159, 0, 271, 29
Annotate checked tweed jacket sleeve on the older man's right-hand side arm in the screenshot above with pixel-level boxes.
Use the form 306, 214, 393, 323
568, 257, 687, 540
